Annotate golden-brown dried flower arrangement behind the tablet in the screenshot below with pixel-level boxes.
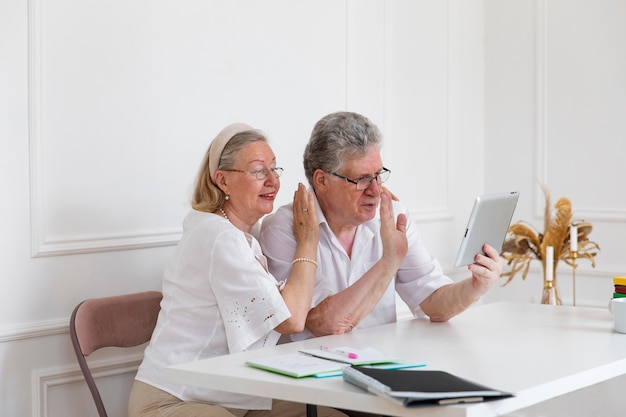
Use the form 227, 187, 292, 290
501, 187, 600, 286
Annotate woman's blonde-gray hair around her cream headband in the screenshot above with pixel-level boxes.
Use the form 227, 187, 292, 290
191, 130, 267, 213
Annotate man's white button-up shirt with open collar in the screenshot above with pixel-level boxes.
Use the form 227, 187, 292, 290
260, 193, 453, 340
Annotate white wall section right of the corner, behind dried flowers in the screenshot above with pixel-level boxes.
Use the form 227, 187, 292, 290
484, 0, 626, 308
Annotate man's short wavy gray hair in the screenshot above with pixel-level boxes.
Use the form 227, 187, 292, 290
303, 112, 383, 187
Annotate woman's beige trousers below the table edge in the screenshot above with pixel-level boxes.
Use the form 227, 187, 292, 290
128, 381, 346, 417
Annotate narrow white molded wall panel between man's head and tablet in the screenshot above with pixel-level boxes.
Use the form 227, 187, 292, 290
381, 1, 455, 219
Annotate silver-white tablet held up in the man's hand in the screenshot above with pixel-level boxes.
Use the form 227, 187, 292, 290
454, 191, 519, 267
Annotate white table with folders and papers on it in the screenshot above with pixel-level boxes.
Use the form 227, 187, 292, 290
166, 303, 626, 417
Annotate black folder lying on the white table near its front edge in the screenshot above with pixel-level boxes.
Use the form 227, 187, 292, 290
343, 366, 512, 407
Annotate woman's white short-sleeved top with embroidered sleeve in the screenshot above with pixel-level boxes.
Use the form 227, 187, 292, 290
136, 210, 290, 409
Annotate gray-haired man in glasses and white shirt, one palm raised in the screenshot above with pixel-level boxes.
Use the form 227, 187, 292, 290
260, 112, 502, 340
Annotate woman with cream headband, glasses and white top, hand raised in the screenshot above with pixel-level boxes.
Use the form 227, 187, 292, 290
128, 124, 341, 417
